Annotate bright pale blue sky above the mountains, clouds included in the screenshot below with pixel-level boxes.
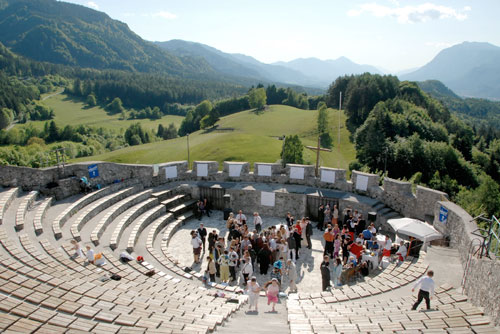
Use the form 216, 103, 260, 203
67, 0, 500, 72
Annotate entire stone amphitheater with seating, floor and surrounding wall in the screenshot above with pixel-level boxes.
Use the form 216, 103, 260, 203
0, 161, 500, 334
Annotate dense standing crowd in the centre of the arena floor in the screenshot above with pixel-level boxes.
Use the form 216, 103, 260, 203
191, 210, 313, 291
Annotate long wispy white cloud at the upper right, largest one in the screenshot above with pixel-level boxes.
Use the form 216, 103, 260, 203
347, 2, 471, 23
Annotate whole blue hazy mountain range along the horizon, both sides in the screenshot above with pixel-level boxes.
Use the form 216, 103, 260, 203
0, 0, 500, 99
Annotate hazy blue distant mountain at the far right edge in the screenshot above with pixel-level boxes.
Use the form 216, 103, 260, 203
400, 42, 500, 100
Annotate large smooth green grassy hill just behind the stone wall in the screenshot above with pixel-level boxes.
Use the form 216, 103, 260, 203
73, 105, 355, 168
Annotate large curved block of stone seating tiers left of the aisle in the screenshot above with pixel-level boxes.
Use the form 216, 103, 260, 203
0, 184, 246, 333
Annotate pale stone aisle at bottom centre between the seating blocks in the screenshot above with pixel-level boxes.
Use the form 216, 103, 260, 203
215, 297, 290, 334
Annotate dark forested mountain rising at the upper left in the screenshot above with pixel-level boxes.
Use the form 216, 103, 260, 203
0, 0, 213, 75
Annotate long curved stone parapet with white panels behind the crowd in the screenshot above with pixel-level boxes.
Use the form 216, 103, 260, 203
0, 161, 447, 222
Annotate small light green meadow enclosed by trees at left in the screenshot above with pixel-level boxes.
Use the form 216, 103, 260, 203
16, 94, 187, 132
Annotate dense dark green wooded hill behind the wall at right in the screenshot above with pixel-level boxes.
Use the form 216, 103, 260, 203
326, 74, 500, 215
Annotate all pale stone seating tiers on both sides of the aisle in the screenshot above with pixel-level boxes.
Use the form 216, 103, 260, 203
0, 182, 496, 334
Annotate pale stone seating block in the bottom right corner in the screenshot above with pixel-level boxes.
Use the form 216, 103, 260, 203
287, 285, 497, 334
